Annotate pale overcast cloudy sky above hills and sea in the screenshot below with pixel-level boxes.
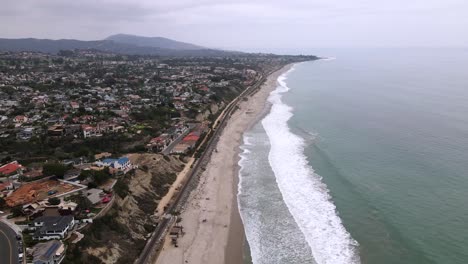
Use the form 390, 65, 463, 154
0, 0, 468, 51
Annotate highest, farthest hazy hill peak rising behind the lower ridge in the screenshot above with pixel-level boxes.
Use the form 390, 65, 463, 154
106, 34, 206, 50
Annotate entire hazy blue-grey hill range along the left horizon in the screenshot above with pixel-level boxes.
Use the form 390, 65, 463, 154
0, 34, 237, 56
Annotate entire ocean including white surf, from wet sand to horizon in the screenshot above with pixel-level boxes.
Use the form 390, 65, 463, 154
238, 48, 468, 264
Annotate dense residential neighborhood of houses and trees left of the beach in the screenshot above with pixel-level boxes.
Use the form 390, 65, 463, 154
0, 50, 314, 263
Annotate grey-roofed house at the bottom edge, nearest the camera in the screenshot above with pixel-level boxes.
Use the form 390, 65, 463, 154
32, 240, 65, 264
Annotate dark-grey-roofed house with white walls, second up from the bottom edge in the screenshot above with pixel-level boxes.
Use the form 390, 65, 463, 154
29, 215, 75, 240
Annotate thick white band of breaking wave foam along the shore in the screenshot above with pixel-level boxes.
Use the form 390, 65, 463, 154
262, 68, 360, 264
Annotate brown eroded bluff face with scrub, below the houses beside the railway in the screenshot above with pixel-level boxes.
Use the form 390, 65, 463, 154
67, 154, 184, 264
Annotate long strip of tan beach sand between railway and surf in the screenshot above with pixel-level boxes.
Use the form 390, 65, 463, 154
156, 66, 290, 264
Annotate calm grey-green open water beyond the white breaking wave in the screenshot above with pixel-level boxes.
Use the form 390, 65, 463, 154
283, 50, 468, 264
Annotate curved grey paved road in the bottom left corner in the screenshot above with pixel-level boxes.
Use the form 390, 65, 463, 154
0, 222, 19, 264
